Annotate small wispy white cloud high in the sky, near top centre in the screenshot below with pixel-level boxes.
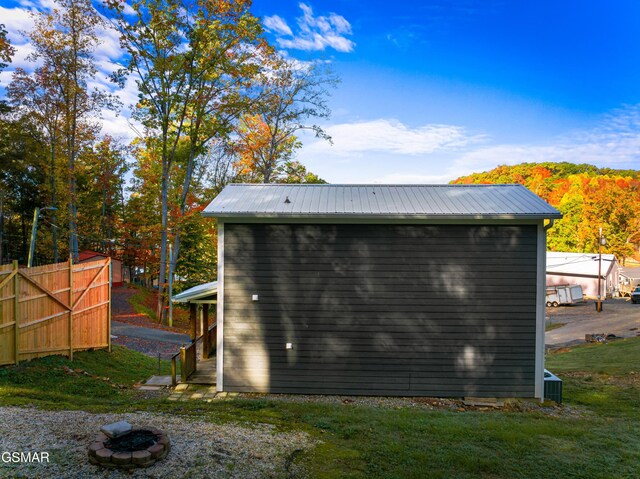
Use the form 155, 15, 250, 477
264, 3, 355, 52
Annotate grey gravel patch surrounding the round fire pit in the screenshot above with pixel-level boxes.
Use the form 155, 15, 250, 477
0, 407, 314, 479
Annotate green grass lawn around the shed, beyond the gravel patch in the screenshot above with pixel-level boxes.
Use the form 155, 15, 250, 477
0, 338, 640, 478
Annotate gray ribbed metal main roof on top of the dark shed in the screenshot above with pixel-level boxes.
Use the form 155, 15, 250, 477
202, 184, 562, 219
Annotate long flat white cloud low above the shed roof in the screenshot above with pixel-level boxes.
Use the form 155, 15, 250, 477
309, 119, 483, 156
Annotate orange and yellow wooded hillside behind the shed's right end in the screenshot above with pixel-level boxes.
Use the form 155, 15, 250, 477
453, 163, 640, 264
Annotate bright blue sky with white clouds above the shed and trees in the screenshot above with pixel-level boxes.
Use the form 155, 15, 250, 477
0, 0, 640, 183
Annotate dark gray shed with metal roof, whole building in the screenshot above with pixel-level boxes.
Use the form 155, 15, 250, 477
203, 184, 561, 398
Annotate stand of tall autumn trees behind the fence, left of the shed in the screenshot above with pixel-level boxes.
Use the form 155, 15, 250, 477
0, 0, 330, 324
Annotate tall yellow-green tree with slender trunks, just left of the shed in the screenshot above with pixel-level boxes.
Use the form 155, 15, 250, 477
107, 0, 269, 321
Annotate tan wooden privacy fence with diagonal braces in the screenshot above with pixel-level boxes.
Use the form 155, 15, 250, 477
0, 258, 111, 365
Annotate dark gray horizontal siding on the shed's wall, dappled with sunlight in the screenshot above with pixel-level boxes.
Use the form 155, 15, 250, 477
224, 223, 537, 397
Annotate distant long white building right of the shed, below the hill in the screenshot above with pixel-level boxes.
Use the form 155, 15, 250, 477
547, 251, 620, 298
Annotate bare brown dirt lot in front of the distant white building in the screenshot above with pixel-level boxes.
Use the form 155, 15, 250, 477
546, 298, 640, 346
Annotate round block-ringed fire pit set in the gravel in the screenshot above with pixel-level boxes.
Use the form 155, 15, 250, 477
88, 427, 171, 469
